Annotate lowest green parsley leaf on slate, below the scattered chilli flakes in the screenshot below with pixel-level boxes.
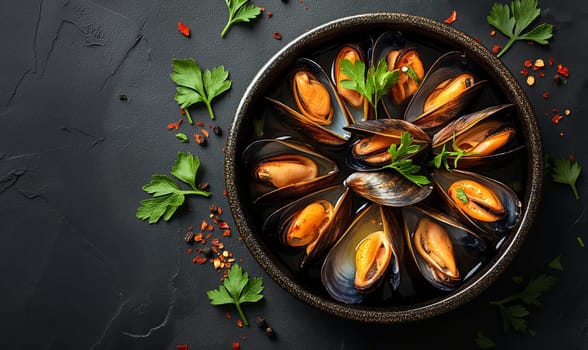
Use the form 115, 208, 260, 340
207, 264, 263, 326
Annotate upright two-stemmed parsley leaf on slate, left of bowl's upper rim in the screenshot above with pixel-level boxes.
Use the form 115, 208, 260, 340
170, 58, 231, 124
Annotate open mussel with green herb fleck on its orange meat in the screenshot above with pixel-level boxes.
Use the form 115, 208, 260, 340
431, 170, 522, 244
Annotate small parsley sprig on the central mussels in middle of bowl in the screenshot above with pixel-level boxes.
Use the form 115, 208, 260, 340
384, 132, 431, 186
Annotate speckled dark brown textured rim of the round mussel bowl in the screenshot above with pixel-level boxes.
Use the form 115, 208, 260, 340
224, 12, 543, 324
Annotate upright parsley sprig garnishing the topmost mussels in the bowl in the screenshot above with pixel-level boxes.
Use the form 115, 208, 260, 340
341, 59, 400, 119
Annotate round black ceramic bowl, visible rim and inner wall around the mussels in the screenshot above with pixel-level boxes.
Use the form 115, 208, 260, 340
225, 13, 543, 323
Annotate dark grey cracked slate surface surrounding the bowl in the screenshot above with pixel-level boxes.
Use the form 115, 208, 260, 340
0, 0, 588, 349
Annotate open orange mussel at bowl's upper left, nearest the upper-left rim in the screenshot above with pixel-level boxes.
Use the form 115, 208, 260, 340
267, 58, 353, 146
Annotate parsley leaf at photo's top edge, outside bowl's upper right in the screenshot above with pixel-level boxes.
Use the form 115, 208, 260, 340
486, 0, 553, 58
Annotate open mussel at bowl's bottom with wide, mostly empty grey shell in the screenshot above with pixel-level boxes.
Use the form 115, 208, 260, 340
321, 204, 404, 304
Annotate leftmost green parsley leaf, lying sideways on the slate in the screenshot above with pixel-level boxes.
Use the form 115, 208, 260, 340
136, 152, 210, 224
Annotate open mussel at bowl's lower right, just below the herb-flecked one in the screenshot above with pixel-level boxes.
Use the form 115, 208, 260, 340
401, 205, 486, 291
